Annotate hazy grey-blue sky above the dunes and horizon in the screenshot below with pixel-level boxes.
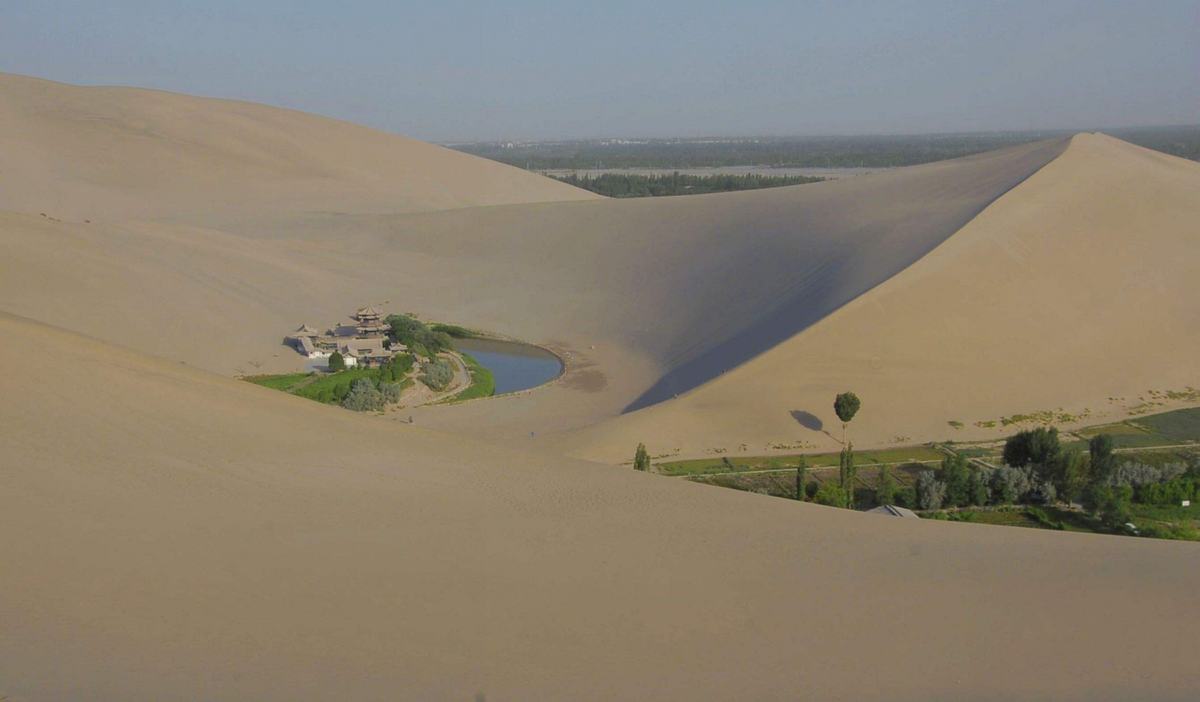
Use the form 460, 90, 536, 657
0, 0, 1200, 140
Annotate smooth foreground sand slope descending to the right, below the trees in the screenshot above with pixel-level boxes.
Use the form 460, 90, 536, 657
7, 314, 1200, 701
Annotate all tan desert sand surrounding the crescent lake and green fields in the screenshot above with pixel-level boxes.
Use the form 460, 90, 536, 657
0, 76, 1200, 701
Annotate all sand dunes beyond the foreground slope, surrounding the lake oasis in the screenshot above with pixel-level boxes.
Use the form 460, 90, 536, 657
0, 77, 1200, 461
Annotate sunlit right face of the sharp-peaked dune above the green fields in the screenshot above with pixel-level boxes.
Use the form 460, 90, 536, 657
572, 134, 1200, 458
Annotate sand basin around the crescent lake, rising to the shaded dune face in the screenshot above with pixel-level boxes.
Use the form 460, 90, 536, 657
0, 132, 1063, 410
